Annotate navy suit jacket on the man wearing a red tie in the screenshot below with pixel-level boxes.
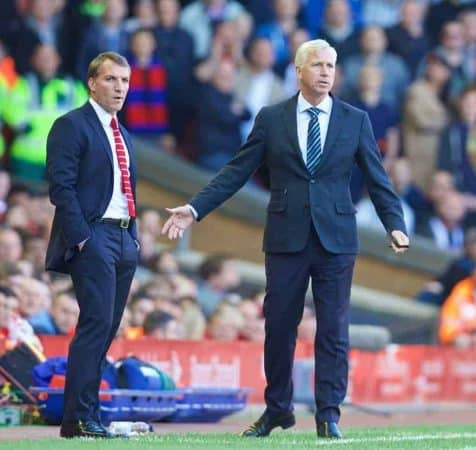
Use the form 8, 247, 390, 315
46, 102, 137, 273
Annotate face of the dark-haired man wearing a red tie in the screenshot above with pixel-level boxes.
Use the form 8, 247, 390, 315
88, 59, 131, 115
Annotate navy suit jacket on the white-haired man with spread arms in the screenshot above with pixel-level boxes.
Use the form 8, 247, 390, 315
190, 95, 406, 253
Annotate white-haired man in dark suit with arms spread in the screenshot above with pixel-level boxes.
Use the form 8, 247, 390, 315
162, 39, 408, 438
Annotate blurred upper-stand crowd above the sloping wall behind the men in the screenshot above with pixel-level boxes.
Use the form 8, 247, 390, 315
0, 0, 476, 246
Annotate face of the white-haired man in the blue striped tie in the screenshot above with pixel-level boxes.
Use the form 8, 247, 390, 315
297, 48, 336, 97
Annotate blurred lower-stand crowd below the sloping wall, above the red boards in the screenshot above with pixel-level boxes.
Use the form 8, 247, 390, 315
0, 166, 313, 350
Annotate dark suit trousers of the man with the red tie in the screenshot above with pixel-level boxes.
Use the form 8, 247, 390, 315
63, 223, 137, 423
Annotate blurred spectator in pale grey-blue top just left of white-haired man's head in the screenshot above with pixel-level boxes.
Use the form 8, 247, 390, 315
234, 38, 286, 142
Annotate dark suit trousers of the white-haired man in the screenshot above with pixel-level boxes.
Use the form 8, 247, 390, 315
264, 230, 355, 422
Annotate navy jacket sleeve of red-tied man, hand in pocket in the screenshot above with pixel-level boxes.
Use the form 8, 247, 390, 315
46, 112, 91, 247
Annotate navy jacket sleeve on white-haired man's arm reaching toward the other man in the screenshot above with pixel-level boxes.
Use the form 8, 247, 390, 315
189, 105, 266, 220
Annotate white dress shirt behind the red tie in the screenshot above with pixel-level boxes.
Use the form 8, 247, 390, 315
89, 98, 129, 219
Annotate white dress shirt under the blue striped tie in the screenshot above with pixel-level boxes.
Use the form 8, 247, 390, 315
296, 92, 332, 163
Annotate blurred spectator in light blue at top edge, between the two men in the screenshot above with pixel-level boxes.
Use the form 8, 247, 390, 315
179, 0, 246, 60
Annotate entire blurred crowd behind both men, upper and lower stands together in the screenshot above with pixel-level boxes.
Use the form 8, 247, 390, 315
0, 0, 476, 350
